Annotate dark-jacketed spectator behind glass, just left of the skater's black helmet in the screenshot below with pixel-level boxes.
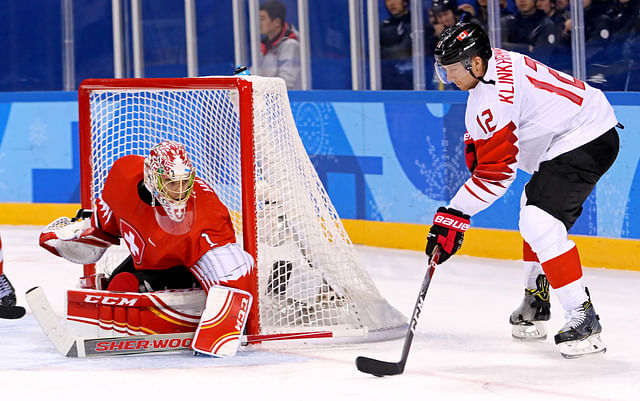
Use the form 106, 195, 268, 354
380, 0, 435, 89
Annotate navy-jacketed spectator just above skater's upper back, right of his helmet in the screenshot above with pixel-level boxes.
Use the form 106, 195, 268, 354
502, 0, 559, 63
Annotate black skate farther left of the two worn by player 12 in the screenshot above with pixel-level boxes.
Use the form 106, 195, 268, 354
509, 274, 551, 340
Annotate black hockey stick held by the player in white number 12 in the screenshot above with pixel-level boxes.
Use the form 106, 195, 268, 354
356, 246, 440, 377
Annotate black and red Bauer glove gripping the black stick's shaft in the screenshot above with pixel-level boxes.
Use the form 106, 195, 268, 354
426, 206, 470, 264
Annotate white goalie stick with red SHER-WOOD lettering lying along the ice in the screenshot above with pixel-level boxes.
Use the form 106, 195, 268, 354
25, 287, 334, 358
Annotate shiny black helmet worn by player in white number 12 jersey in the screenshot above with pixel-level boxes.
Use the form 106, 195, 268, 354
433, 22, 492, 69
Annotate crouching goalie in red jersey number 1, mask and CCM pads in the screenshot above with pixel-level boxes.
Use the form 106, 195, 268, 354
40, 141, 254, 356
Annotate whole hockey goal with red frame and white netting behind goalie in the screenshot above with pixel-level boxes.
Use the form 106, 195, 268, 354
79, 77, 406, 340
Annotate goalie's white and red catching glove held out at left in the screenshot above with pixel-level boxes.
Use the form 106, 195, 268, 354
40, 209, 120, 264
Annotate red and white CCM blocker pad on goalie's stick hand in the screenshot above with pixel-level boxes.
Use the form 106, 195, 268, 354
191, 286, 253, 357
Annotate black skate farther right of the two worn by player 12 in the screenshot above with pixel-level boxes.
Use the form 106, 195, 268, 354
554, 288, 607, 359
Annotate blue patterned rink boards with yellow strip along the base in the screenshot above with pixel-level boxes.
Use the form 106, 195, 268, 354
0, 91, 640, 269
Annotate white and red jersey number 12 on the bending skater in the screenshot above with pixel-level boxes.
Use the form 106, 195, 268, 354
449, 49, 617, 216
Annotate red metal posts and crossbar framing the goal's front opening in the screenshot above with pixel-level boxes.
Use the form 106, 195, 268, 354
78, 77, 260, 334
